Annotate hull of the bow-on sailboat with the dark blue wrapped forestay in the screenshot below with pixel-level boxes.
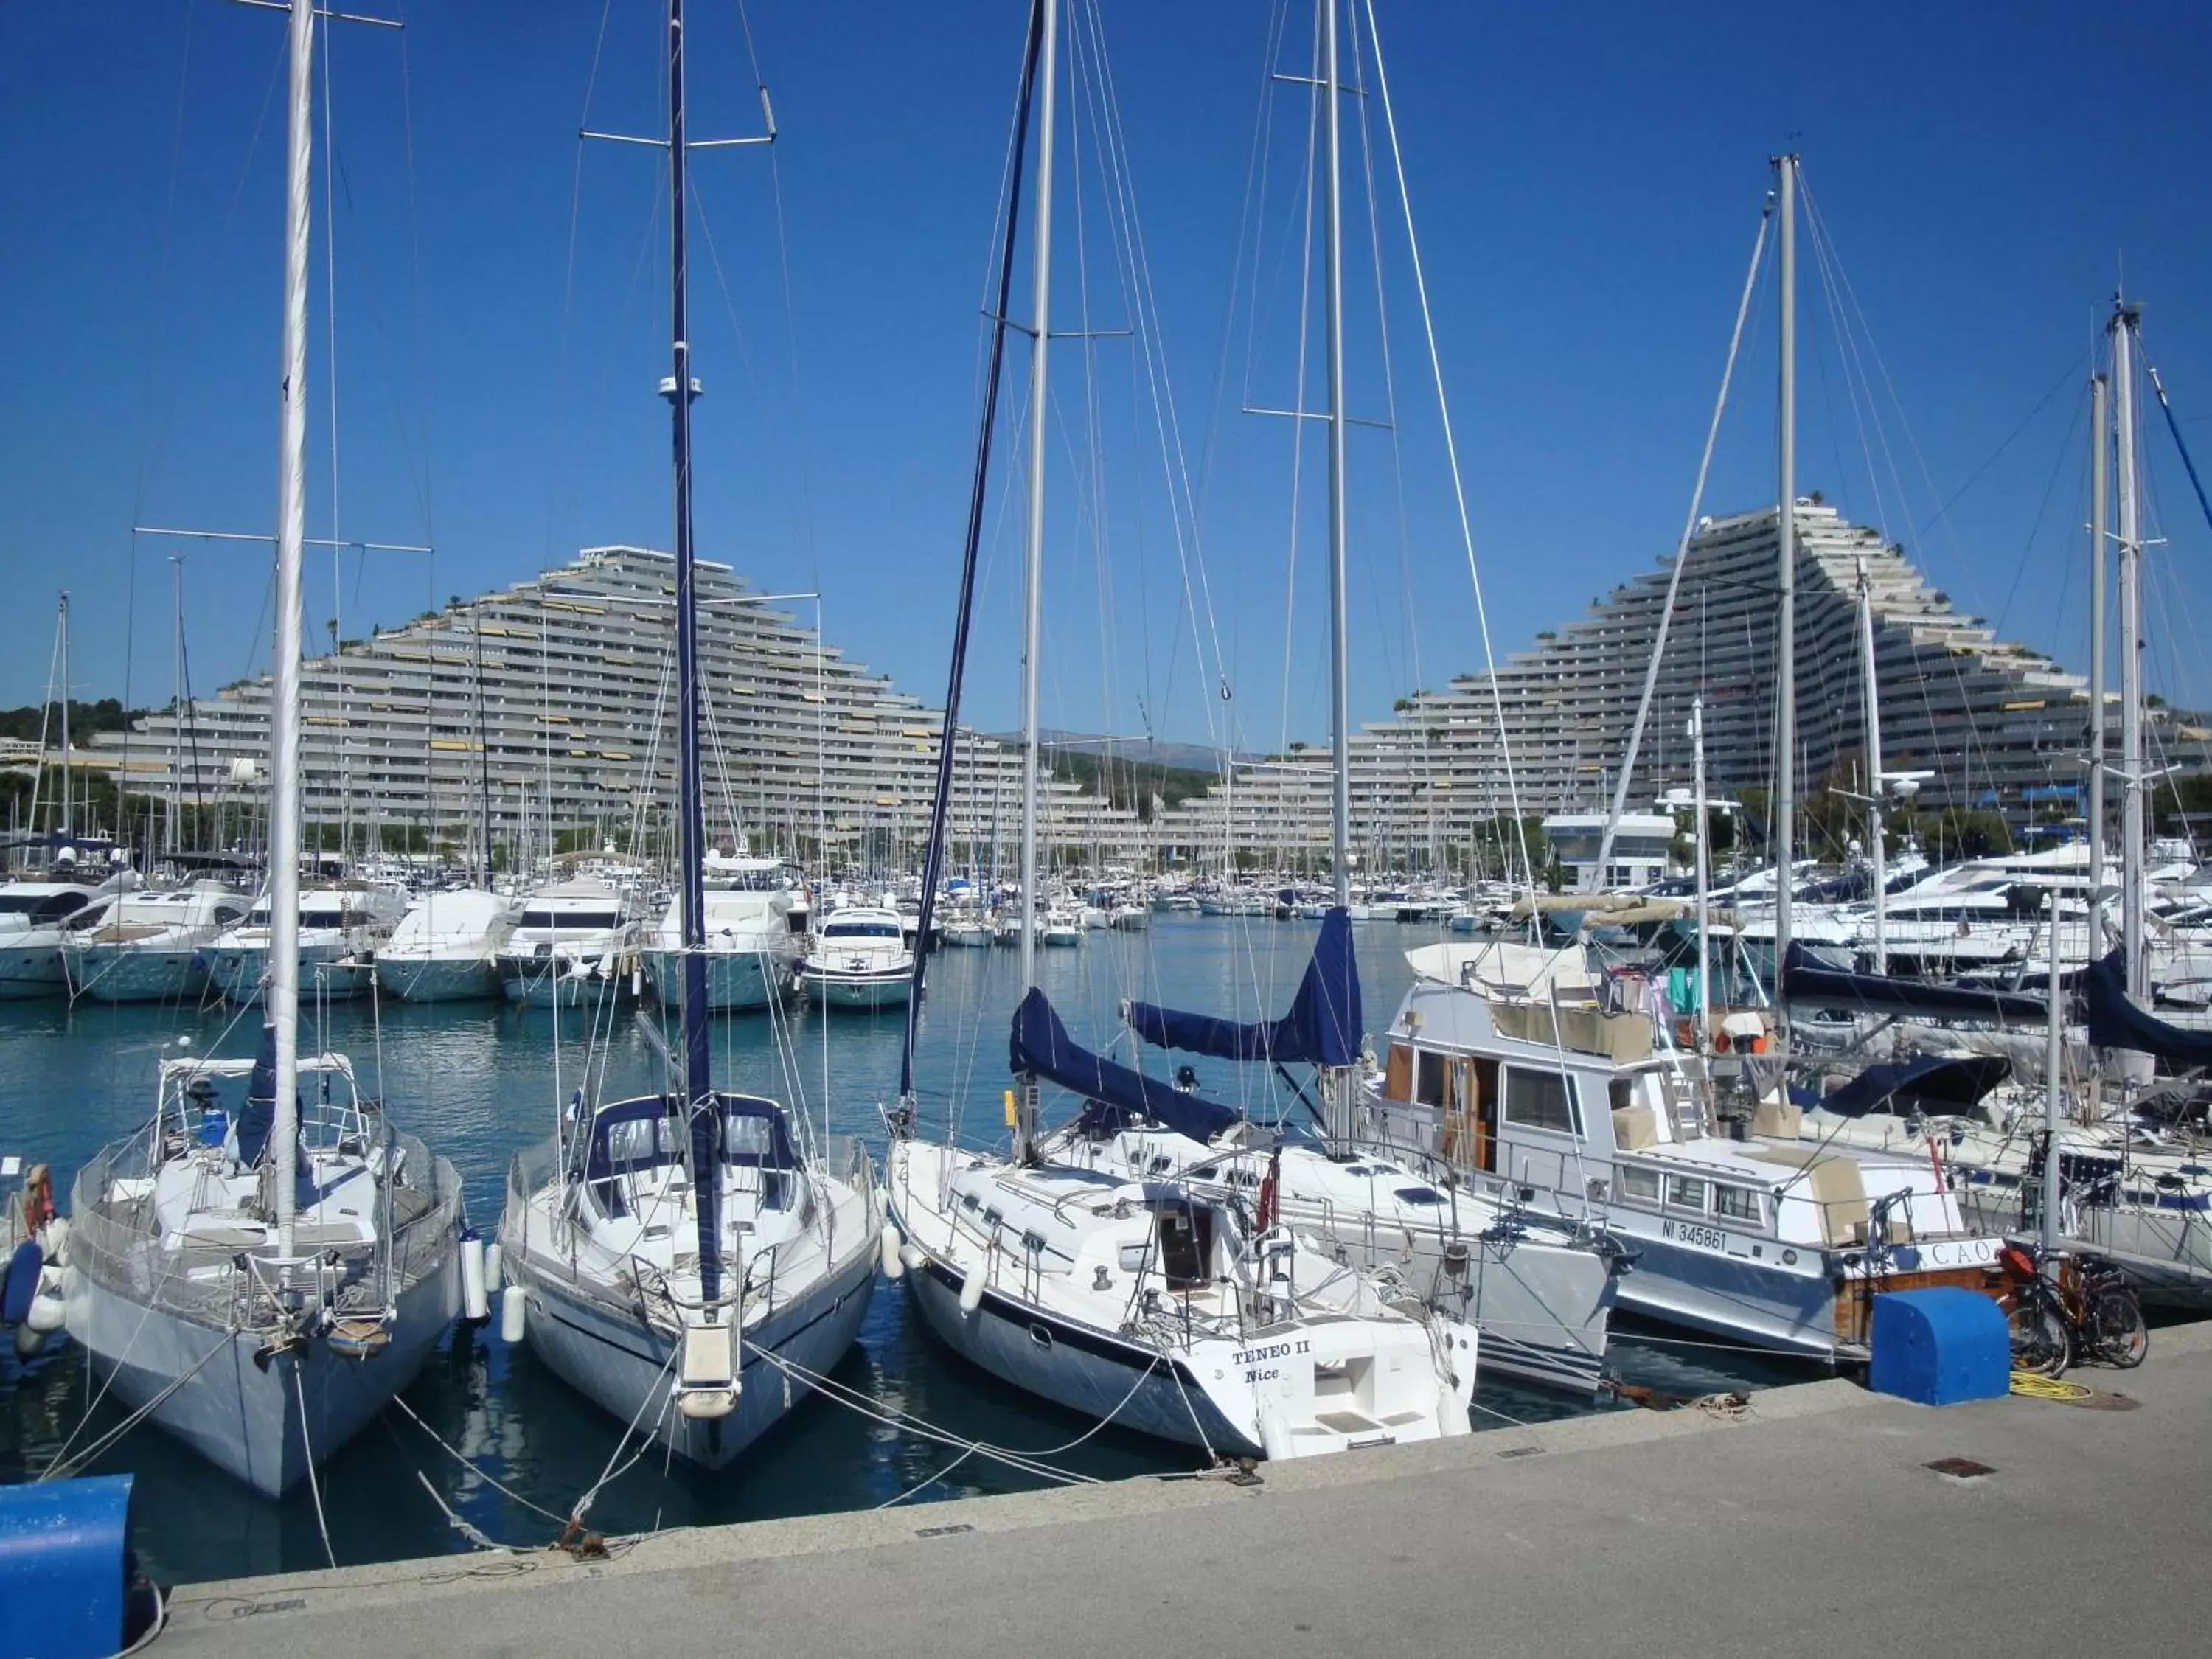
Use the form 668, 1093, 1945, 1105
518, 1250, 876, 1469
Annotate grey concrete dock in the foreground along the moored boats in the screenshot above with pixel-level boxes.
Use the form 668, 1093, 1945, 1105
155, 1323, 2212, 1659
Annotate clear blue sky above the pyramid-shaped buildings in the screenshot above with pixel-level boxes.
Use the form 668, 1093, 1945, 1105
0, 0, 2212, 748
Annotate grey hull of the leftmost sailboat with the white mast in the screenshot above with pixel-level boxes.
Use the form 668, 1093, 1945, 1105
69, 1250, 460, 1498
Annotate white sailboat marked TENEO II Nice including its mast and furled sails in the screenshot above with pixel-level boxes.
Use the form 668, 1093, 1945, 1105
887, 0, 1475, 1458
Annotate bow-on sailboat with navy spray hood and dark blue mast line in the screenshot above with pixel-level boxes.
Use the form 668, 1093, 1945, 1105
500, 0, 883, 1469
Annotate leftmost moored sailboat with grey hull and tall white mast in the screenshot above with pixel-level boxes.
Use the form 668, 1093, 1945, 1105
64, 0, 462, 1498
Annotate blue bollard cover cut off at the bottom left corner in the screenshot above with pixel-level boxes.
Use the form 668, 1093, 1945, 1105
0, 1475, 131, 1659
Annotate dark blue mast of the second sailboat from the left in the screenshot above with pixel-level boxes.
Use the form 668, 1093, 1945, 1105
664, 0, 714, 1110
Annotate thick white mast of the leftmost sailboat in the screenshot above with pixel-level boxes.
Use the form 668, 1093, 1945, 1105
265, 0, 314, 1256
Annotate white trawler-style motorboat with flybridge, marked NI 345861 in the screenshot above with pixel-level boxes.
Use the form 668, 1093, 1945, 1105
1367, 942, 2004, 1360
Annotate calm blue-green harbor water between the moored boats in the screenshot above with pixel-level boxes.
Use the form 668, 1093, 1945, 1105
0, 916, 1803, 1582
